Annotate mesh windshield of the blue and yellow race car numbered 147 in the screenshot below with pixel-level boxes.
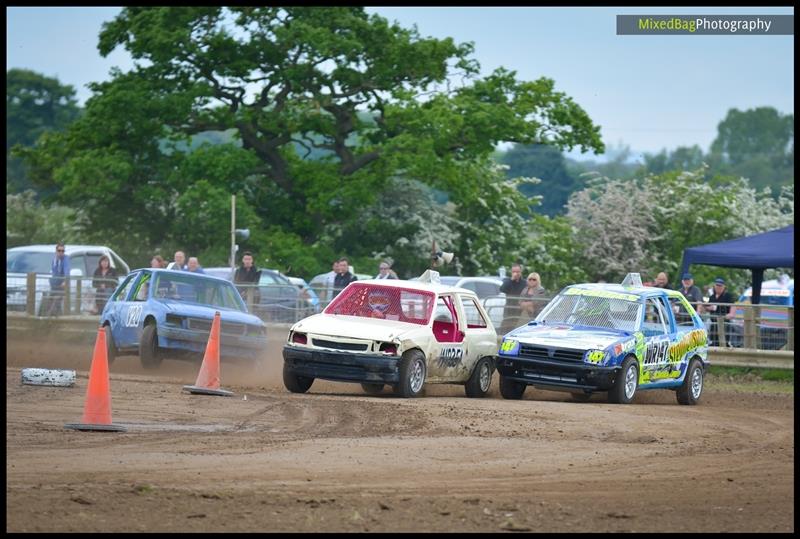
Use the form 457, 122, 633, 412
536, 289, 642, 331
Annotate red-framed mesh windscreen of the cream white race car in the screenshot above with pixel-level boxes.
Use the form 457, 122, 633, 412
325, 282, 436, 325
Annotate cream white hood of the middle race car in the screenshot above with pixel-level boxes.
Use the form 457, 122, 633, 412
292, 314, 425, 341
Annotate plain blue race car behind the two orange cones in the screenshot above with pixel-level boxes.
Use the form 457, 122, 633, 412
100, 268, 267, 369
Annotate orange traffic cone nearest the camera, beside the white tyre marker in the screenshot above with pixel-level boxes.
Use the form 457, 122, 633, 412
64, 327, 128, 432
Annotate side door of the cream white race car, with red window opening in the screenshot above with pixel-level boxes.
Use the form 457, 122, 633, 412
428, 294, 465, 381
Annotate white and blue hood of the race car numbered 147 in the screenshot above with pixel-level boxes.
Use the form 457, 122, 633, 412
506, 324, 632, 350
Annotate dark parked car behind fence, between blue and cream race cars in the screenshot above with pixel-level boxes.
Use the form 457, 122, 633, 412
203, 268, 313, 323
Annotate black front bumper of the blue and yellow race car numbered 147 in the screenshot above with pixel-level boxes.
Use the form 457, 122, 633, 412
497, 356, 621, 391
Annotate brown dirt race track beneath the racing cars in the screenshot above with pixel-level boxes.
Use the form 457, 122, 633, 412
6, 338, 794, 532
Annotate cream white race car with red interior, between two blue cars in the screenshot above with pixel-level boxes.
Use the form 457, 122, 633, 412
283, 270, 497, 397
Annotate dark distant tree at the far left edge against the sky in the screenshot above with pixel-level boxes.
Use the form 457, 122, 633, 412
6, 68, 80, 193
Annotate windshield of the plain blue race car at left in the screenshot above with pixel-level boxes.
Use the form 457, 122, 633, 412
153, 271, 247, 312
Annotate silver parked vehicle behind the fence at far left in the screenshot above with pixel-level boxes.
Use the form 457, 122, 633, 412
6, 243, 130, 315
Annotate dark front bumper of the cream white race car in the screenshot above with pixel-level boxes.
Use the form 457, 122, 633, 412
283, 345, 400, 384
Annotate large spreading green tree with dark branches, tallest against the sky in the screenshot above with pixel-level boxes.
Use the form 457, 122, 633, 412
15, 7, 602, 266
